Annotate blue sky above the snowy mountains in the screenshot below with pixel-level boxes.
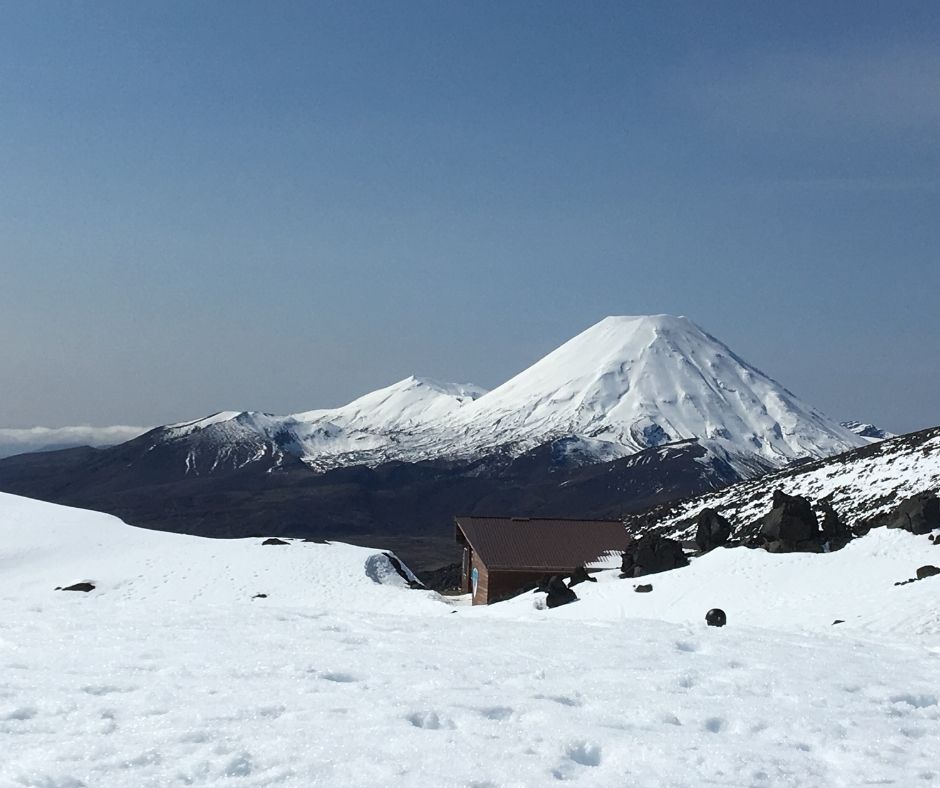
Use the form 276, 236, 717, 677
0, 0, 940, 431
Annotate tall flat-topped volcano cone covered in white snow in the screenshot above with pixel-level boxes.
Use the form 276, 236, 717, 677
448, 315, 860, 471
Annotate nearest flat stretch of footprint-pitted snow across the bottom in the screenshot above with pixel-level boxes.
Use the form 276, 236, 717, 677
0, 595, 940, 788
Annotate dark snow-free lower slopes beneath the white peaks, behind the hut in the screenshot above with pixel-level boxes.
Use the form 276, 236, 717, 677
0, 433, 739, 570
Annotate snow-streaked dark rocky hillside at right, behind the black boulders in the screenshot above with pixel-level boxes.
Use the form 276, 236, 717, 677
633, 427, 940, 540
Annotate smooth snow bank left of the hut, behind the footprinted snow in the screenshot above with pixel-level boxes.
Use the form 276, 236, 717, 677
0, 493, 446, 612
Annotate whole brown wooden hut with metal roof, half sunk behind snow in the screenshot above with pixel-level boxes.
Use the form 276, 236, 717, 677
454, 517, 631, 605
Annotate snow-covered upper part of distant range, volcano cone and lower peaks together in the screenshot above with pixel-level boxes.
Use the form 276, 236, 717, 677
151, 315, 866, 476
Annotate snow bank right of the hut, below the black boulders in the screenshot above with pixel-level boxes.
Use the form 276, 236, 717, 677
488, 528, 940, 648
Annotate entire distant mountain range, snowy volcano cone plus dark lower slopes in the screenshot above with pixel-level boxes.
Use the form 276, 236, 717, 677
0, 315, 867, 567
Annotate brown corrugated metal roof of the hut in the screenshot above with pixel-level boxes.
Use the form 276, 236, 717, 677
454, 517, 632, 572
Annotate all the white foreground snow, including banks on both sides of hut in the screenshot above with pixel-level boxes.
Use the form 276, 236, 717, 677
0, 495, 940, 788
